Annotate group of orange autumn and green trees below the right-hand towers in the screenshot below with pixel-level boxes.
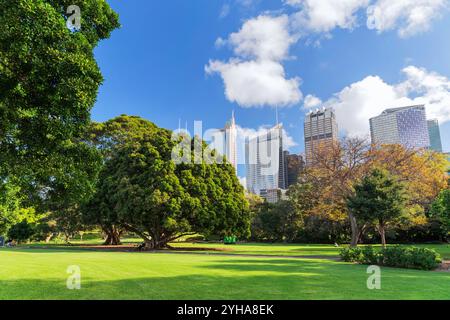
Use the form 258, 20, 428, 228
252, 138, 450, 246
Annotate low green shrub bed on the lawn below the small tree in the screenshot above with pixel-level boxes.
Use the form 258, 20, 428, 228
339, 246, 442, 270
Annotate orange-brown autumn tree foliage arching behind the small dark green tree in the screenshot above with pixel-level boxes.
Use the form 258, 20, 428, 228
290, 138, 447, 246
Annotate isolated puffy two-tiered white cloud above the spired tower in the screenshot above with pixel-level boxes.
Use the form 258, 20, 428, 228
205, 15, 302, 107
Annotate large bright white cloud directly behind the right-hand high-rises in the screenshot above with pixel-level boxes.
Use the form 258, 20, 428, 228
324, 66, 450, 136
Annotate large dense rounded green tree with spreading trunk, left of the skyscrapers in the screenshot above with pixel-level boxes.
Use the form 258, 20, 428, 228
89, 117, 249, 248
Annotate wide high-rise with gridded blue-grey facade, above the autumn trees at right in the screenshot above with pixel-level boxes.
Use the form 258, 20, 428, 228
370, 105, 430, 149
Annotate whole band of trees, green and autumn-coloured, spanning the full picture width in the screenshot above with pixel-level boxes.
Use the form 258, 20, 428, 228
0, 0, 450, 248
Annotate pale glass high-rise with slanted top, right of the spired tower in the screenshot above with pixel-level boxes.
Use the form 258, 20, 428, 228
245, 125, 286, 195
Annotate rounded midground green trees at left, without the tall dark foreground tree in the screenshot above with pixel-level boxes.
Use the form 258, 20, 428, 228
1, 115, 250, 249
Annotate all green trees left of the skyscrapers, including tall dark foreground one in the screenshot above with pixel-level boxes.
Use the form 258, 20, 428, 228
0, 0, 249, 248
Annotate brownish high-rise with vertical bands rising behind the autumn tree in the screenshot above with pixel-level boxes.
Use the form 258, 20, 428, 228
305, 108, 338, 166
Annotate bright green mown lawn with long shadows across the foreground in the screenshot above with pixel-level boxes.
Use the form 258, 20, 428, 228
0, 245, 450, 299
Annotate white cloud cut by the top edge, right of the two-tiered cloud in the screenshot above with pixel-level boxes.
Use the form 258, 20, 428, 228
285, 0, 369, 34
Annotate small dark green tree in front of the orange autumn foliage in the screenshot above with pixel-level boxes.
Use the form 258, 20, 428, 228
347, 169, 407, 247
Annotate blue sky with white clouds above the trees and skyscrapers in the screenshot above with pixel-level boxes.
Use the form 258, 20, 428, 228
93, 0, 450, 162
